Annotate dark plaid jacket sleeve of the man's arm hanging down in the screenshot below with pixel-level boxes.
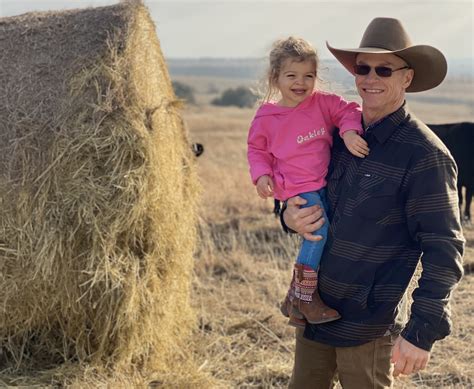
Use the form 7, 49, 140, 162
401, 150, 465, 351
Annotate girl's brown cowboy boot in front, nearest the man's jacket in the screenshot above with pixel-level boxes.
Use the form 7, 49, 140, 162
294, 264, 341, 324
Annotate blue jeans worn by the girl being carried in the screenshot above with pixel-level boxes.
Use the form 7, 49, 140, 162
296, 188, 329, 270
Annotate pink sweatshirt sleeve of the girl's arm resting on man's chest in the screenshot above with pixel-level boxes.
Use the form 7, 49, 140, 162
327, 95, 364, 135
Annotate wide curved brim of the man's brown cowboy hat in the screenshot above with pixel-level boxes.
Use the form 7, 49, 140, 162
326, 42, 448, 92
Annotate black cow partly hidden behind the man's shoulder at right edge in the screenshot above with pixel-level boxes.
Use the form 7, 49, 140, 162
428, 122, 474, 223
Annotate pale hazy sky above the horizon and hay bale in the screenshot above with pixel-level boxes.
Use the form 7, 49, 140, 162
0, 0, 474, 60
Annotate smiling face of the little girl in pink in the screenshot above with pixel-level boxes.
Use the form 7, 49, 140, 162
276, 58, 316, 107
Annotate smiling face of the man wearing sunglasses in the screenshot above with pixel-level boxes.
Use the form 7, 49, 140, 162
355, 53, 414, 113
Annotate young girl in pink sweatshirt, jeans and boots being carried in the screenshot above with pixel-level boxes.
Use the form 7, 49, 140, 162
248, 37, 369, 327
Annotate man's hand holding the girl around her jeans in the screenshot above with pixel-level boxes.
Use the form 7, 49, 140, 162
283, 196, 324, 241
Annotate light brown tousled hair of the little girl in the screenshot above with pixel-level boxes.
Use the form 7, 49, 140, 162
263, 36, 319, 102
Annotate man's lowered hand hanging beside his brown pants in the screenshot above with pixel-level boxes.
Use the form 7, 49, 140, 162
391, 336, 430, 377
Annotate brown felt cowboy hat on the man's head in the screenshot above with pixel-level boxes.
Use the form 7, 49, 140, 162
326, 18, 448, 92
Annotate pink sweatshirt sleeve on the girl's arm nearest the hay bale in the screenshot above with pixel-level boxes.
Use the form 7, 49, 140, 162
247, 119, 273, 185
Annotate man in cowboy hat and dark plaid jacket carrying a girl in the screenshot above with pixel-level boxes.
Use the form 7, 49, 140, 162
282, 18, 464, 389
